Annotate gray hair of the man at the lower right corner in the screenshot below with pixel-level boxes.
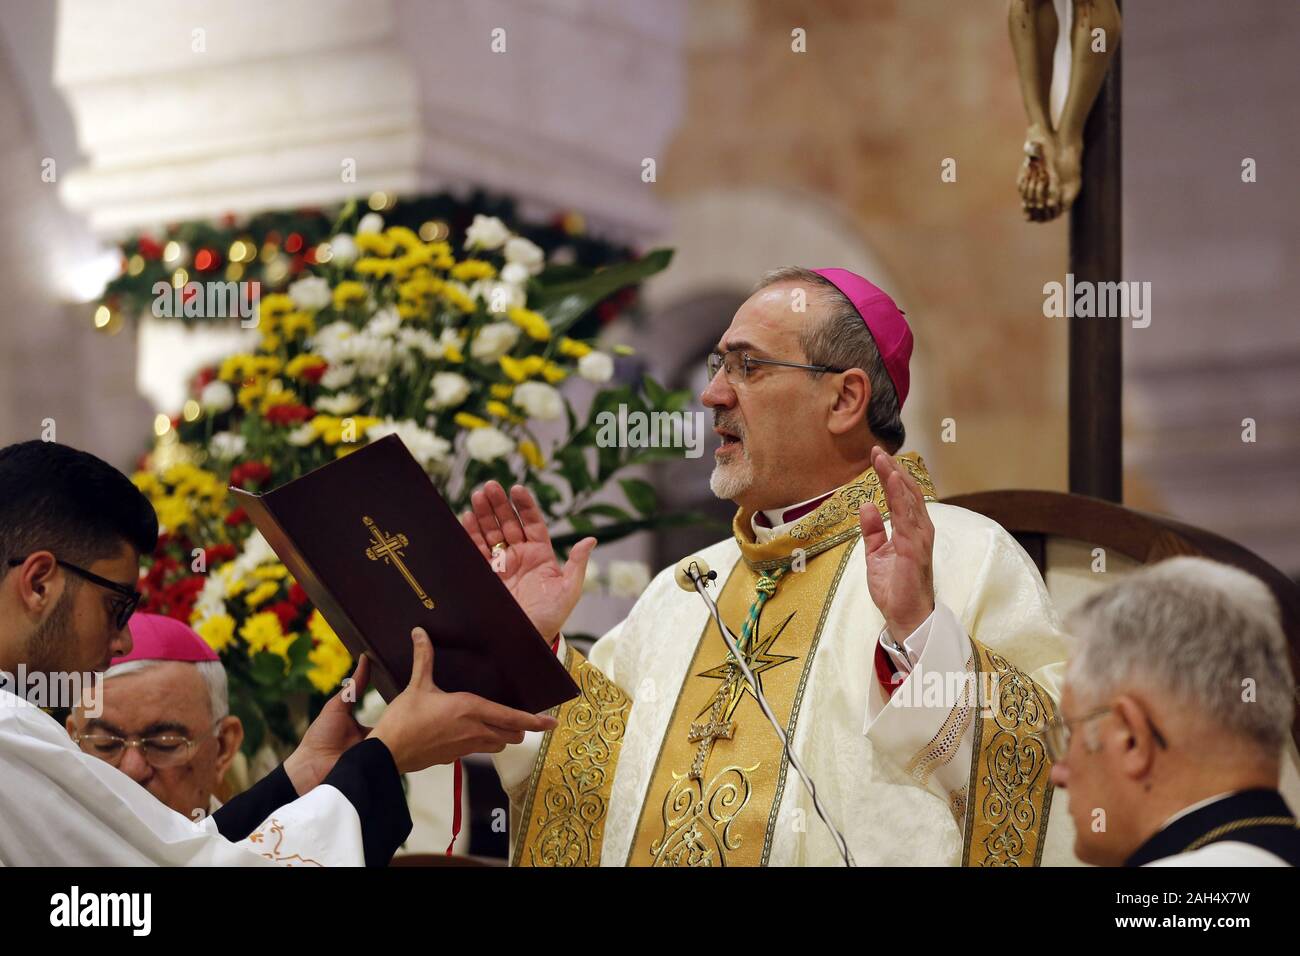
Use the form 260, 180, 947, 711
1066, 558, 1295, 754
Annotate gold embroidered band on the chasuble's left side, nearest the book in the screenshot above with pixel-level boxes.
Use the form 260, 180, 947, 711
514, 648, 632, 866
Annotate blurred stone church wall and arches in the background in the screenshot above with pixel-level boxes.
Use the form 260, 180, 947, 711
0, 0, 1300, 858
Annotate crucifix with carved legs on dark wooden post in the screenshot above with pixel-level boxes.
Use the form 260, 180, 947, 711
1008, 0, 1123, 502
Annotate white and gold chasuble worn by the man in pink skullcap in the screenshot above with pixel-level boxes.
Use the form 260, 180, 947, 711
495, 455, 1074, 866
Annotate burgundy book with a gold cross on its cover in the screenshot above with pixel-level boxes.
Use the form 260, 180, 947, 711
230, 436, 577, 713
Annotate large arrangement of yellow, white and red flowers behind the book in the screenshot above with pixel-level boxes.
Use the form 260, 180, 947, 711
134, 205, 693, 754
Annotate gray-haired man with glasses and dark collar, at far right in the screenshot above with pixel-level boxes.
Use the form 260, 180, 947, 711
1048, 558, 1300, 866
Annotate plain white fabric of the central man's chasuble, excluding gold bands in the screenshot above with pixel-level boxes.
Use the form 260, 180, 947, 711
495, 503, 1078, 866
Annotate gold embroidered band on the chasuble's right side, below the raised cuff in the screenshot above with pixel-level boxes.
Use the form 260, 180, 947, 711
962, 639, 1056, 866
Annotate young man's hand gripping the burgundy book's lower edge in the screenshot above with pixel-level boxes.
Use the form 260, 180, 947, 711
371, 627, 555, 774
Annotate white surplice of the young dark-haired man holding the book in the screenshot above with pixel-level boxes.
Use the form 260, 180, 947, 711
0, 689, 364, 866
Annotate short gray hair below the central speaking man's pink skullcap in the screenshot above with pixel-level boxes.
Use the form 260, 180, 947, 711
750, 265, 907, 454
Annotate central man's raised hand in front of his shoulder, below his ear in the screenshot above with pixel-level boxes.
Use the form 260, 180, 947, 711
858, 446, 935, 645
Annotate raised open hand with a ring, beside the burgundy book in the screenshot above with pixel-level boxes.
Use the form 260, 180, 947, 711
460, 481, 595, 641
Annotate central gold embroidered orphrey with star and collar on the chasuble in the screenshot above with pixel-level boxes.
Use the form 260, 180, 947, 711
627, 455, 935, 866
